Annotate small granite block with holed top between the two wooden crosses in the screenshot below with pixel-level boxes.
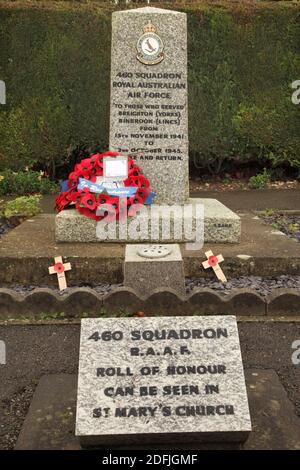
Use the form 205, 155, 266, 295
124, 244, 186, 296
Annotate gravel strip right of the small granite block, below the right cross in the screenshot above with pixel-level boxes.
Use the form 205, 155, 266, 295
186, 274, 300, 297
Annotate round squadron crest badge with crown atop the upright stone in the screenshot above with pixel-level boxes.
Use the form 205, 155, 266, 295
136, 21, 164, 65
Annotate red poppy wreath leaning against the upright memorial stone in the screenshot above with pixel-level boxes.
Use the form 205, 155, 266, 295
56, 152, 153, 221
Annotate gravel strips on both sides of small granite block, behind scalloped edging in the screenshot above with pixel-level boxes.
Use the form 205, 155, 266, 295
3, 274, 300, 297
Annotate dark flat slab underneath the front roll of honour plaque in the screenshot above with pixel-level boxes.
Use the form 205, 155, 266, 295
15, 369, 300, 450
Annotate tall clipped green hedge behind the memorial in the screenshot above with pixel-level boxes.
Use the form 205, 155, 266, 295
0, 2, 300, 176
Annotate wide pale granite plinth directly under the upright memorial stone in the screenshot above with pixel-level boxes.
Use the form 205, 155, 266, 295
55, 198, 241, 243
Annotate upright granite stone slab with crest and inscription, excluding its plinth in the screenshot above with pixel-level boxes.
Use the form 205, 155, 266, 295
110, 7, 189, 204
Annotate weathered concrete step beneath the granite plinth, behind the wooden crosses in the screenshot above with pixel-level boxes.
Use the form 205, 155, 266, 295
0, 213, 300, 286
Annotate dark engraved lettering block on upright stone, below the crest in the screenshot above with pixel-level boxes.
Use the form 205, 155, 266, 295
112, 71, 187, 161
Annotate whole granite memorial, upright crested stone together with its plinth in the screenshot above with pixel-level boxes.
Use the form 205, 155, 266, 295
55, 7, 241, 244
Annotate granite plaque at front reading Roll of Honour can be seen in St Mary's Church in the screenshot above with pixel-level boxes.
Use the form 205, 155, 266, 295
76, 316, 251, 446
